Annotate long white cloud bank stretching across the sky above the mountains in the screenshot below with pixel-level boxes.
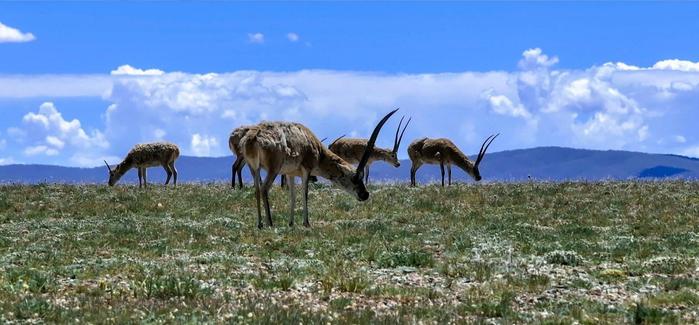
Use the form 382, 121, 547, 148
0, 48, 699, 165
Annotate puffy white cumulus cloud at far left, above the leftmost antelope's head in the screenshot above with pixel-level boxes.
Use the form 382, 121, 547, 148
14, 102, 109, 163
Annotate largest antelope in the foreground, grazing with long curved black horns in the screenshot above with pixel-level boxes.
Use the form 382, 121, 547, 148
240, 109, 397, 228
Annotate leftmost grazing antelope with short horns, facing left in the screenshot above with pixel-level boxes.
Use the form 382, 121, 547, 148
104, 142, 180, 188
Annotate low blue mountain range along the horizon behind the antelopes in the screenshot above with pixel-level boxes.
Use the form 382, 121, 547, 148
0, 147, 699, 183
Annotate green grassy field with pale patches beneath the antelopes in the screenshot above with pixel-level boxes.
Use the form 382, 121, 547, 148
0, 181, 699, 324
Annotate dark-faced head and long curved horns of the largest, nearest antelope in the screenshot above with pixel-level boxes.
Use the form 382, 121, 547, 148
331, 109, 398, 201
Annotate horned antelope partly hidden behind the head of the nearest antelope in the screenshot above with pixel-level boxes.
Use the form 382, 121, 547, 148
328, 116, 412, 184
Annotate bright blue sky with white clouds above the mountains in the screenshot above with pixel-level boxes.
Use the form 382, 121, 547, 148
0, 2, 699, 166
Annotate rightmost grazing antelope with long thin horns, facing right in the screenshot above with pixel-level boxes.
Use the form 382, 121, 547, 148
408, 133, 500, 186
